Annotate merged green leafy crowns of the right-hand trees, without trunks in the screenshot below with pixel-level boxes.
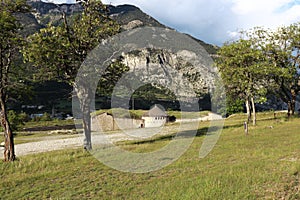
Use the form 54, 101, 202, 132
217, 23, 300, 117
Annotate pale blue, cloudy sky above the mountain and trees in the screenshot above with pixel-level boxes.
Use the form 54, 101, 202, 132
44, 0, 300, 46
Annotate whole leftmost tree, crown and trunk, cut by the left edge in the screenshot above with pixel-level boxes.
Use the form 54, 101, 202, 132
0, 0, 29, 161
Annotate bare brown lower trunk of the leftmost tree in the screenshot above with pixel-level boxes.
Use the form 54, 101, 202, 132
0, 94, 16, 162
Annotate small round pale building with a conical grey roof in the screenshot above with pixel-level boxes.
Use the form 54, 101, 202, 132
142, 104, 168, 128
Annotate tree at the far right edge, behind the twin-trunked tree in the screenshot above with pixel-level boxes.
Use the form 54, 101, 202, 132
263, 22, 300, 116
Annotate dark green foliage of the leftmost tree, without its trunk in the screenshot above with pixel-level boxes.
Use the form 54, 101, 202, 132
0, 0, 29, 92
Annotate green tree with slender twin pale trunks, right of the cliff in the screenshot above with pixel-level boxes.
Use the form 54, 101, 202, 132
217, 32, 273, 125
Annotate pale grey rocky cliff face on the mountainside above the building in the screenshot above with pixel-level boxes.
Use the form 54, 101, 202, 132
122, 48, 216, 97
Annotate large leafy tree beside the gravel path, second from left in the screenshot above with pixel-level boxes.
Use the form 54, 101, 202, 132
23, 0, 122, 150
